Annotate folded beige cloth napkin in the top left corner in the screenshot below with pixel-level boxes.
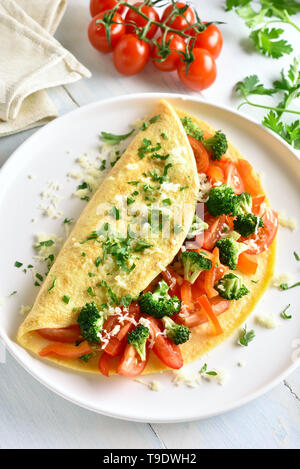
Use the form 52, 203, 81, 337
0, 0, 90, 136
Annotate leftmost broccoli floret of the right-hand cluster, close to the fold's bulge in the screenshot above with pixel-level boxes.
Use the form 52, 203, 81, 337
206, 184, 237, 217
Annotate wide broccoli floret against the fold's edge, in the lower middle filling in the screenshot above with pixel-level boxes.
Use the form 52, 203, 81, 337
138, 280, 181, 318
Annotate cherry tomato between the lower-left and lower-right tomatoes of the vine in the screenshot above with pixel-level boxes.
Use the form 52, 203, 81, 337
152, 33, 186, 72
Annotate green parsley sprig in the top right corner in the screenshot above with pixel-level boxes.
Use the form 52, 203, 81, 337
226, 0, 300, 59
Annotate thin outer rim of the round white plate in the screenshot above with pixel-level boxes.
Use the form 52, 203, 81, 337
0, 92, 300, 423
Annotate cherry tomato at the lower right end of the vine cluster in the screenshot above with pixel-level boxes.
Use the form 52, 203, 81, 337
177, 49, 217, 91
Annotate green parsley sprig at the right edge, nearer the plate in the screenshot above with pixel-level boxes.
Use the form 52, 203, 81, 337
236, 58, 300, 150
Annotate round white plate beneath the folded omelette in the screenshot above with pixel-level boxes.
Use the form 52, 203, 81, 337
0, 94, 300, 422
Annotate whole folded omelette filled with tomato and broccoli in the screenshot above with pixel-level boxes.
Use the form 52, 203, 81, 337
17, 100, 278, 377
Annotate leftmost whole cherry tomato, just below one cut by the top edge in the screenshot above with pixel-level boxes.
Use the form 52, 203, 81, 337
88, 11, 126, 54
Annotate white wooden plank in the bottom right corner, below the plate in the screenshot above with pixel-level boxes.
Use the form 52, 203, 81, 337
153, 371, 300, 449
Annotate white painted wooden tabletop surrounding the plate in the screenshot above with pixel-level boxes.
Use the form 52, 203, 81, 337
0, 0, 300, 449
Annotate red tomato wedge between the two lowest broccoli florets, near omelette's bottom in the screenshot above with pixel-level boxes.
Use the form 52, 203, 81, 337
147, 316, 183, 370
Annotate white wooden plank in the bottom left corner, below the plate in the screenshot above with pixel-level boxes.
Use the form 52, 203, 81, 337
0, 353, 162, 449
